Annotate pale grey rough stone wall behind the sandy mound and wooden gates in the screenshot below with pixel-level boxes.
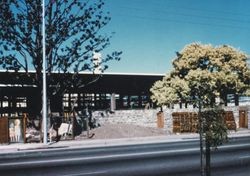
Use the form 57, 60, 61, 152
93, 106, 250, 133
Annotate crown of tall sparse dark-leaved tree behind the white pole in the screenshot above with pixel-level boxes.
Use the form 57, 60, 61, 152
0, 0, 121, 115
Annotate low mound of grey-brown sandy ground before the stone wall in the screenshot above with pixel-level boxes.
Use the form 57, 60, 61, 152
78, 122, 165, 139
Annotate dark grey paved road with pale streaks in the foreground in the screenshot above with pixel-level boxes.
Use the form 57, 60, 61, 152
0, 137, 250, 176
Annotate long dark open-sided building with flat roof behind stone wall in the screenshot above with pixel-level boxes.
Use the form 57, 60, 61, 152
0, 71, 164, 143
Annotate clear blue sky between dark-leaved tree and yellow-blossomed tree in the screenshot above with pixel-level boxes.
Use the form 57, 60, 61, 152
104, 0, 250, 74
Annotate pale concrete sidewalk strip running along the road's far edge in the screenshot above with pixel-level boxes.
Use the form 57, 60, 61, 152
0, 129, 250, 154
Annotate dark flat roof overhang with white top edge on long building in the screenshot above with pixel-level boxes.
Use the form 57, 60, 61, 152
0, 71, 164, 95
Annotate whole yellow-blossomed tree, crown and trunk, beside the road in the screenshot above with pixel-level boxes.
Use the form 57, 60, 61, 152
151, 43, 250, 175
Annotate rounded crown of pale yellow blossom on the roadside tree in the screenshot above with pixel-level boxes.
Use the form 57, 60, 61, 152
151, 43, 250, 107
